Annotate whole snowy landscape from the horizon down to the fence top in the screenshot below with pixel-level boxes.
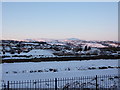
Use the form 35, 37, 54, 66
0, 38, 120, 88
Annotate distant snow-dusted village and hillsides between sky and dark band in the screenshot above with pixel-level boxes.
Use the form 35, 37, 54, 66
0, 40, 120, 60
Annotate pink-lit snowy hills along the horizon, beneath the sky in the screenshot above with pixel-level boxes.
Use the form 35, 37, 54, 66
22, 38, 118, 48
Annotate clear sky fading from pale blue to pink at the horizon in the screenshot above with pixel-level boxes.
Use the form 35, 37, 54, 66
2, 2, 118, 41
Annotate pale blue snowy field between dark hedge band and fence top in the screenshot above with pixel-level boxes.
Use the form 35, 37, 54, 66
1, 59, 118, 82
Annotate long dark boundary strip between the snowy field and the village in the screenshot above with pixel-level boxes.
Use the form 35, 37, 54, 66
2, 55, 120, 63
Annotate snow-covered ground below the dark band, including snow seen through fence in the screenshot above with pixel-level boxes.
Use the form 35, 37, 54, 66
1, 59, 120, 89
